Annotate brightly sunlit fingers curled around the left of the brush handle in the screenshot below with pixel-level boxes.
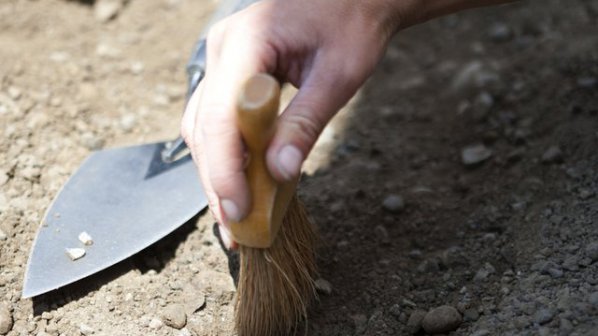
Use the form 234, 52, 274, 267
182, 8, 276, 234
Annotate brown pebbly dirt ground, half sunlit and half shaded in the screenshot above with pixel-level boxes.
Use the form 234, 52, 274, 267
0, 0, 598, 336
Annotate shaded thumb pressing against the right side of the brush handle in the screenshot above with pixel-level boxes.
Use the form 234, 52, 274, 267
267, 55, 358, 182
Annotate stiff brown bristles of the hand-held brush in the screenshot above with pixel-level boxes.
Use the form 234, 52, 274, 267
235, 195, 317, 336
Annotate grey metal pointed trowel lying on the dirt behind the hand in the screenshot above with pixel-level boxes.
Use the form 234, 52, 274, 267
22, 0, 257, 298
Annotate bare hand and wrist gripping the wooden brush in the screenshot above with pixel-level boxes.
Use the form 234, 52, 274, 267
181, 0, 507, 248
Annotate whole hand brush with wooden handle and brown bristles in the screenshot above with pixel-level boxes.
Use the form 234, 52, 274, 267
231, 74, 317, 336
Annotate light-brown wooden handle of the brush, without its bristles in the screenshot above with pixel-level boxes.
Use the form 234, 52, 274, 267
230, 74, 296, 248
